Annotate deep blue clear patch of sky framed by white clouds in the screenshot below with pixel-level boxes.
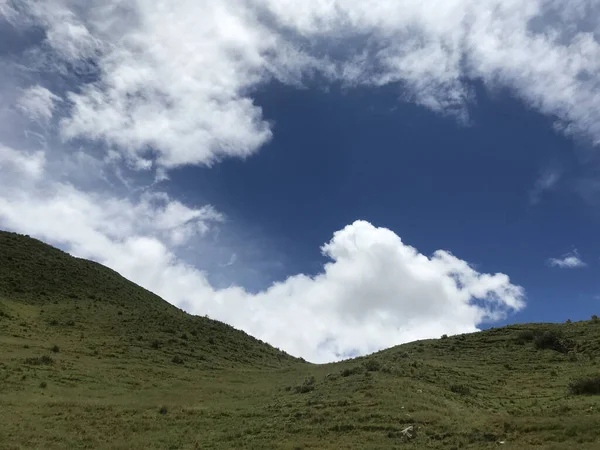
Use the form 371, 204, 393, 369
171, 80, 600, 323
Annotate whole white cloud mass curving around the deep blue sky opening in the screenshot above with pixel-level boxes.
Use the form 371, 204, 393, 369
7, 0, 600, 361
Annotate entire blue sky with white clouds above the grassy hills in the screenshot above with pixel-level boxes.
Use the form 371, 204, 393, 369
0, 0, 600, 362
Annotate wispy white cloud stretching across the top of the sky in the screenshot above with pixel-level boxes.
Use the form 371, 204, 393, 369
5, 0, 600, 168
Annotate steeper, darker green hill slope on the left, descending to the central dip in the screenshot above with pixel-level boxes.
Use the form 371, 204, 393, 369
0, 232, 293, 367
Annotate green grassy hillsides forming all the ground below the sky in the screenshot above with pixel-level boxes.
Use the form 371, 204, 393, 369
0, 233, 600, 449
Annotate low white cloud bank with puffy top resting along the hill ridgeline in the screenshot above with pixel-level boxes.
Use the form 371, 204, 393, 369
0, 148, 524, 362
